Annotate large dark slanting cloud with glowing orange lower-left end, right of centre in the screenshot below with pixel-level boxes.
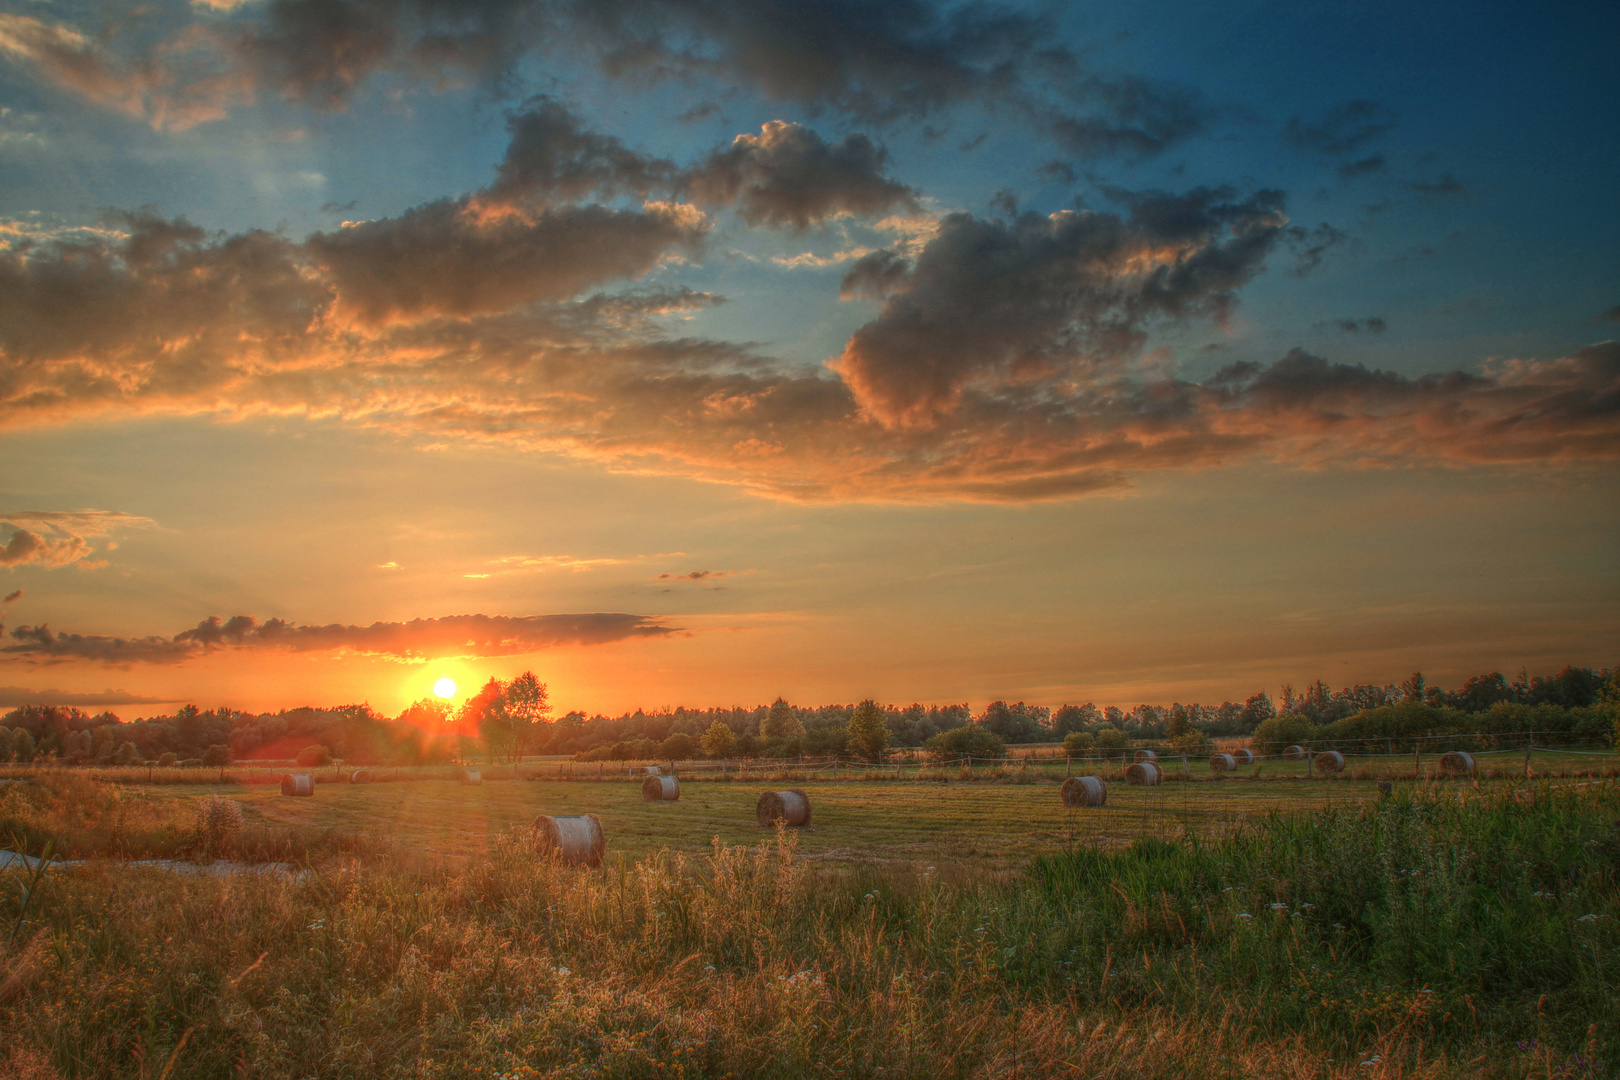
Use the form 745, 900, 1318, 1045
834, 188, 1288, 424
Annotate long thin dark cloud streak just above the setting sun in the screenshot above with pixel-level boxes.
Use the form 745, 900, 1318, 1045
0, 612, 676, 665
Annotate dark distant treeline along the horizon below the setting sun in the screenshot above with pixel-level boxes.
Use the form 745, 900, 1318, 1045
0, 667, 1620, 764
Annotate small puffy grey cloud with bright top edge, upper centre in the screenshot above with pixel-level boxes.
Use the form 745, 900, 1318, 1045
682, 120, 917, 228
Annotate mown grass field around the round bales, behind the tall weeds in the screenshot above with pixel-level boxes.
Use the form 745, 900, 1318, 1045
9, 763, 1607, 873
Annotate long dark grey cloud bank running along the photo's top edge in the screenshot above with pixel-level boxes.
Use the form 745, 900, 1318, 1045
0, 0, 1209, 157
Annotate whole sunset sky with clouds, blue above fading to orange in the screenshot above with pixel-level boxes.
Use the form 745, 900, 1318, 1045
0, 0, 1620, 716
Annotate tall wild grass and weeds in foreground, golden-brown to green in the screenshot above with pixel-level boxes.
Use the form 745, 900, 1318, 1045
0, 776, 1620, 1080
